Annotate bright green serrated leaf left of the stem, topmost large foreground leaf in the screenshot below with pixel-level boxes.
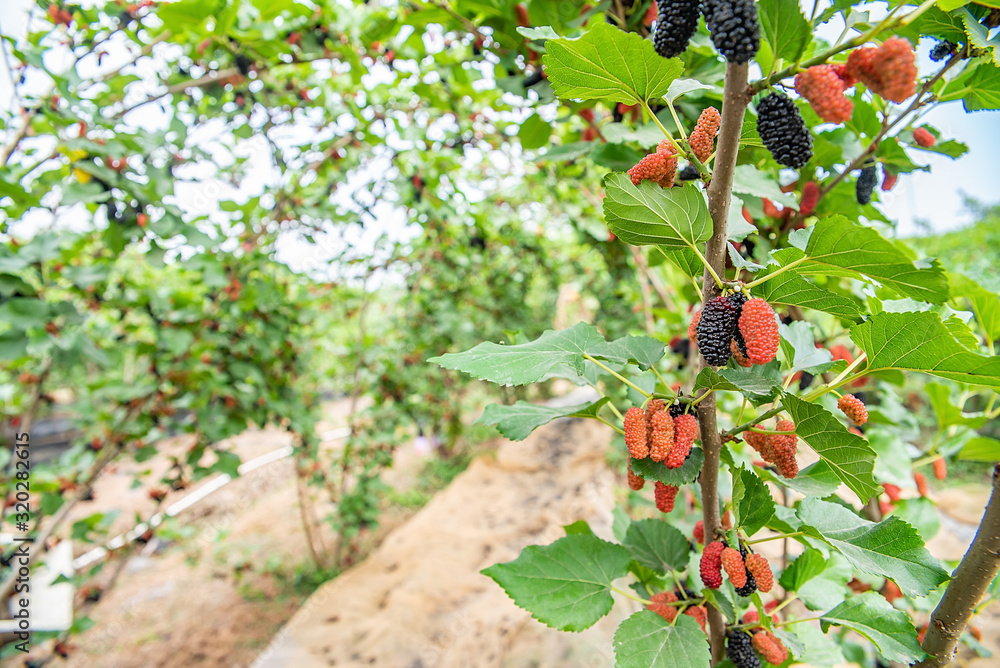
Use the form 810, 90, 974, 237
543, 21, 684, 104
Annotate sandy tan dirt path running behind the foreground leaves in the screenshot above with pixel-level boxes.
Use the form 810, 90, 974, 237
255, 420, 637, 668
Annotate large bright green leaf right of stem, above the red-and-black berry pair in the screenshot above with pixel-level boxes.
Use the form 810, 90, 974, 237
781, 215, 948, 304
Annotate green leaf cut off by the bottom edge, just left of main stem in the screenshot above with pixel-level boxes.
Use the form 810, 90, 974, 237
615, 610, 712, 668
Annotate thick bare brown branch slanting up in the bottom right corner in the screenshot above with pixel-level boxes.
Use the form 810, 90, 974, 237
916, 464, 1000, 668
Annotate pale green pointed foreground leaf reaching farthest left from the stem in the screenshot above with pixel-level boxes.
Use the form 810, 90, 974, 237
427, 322, 605, 385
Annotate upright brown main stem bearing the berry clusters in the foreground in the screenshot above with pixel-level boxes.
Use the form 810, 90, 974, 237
698, 63, 750, 664
